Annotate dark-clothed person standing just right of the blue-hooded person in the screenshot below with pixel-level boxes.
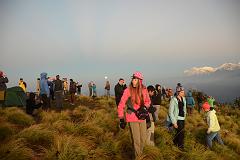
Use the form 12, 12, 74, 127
53, 75, 63, 110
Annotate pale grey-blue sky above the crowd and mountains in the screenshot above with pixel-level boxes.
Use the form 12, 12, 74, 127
0, 0, 240, 94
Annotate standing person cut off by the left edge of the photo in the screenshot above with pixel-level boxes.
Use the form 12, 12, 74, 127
0, 71, 8, 106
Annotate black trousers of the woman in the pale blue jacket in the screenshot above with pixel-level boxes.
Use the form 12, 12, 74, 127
173, 120, 184, 148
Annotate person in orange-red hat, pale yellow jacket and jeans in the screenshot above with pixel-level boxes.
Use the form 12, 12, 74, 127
202, 102, 223, 148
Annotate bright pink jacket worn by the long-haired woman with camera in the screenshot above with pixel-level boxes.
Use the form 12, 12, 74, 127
118, 88, 151, 122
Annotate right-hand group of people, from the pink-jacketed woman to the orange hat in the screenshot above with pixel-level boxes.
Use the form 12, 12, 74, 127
115, 72, 223, 157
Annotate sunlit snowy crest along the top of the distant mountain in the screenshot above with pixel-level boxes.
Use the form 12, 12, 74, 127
184, 62, 240, 76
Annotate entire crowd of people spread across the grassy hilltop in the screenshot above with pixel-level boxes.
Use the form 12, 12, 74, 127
0, 71, 223, 157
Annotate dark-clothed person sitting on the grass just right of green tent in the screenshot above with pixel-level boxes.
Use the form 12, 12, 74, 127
26, 92, 42, 115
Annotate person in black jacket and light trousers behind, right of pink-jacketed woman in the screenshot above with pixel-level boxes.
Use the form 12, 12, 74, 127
152, 84, 162, 121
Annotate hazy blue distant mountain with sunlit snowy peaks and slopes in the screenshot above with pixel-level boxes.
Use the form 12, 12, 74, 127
183, 63, 240, 102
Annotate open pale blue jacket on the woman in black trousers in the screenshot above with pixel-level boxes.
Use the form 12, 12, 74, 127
167, 96, 187, 124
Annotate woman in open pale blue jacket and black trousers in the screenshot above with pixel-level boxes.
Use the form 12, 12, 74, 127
167, 87, 186, 149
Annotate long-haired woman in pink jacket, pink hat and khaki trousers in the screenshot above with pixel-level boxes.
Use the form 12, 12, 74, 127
118, 72, 151, 157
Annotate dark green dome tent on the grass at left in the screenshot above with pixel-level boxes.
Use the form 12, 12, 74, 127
4, 87, 27, 107
